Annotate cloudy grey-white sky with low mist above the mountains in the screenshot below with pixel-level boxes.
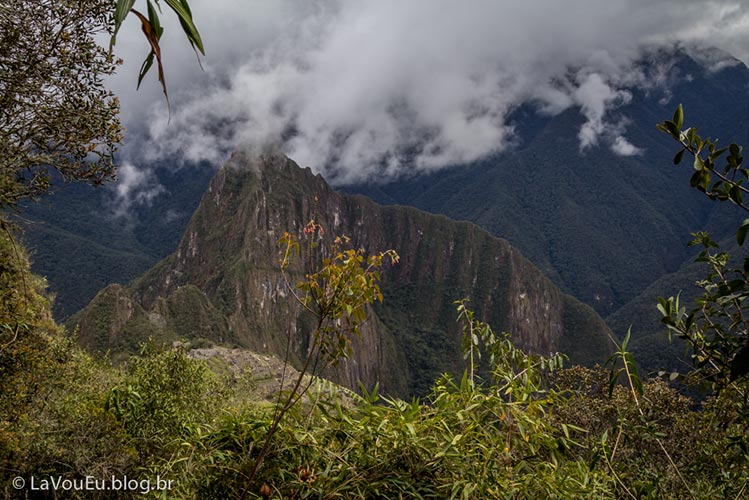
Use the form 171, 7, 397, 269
108, 0, 749, 205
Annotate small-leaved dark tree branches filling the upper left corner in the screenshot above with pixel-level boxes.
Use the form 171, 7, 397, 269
0, 0, 122, 211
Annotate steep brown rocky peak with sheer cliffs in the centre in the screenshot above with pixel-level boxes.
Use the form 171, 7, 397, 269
74, 146, 608, 395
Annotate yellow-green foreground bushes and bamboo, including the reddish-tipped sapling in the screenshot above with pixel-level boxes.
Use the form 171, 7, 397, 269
0, 225, 749, 499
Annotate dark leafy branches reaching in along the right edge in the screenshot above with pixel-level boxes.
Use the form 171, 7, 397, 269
658, 105, 749, 386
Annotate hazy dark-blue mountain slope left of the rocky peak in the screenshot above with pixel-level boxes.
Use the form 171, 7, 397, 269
20, 165, 214, 319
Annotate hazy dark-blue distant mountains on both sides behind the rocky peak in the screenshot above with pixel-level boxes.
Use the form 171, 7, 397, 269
24, 46, 749, 376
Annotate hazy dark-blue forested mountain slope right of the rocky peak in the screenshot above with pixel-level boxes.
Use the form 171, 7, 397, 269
346, 48, 749, 316
